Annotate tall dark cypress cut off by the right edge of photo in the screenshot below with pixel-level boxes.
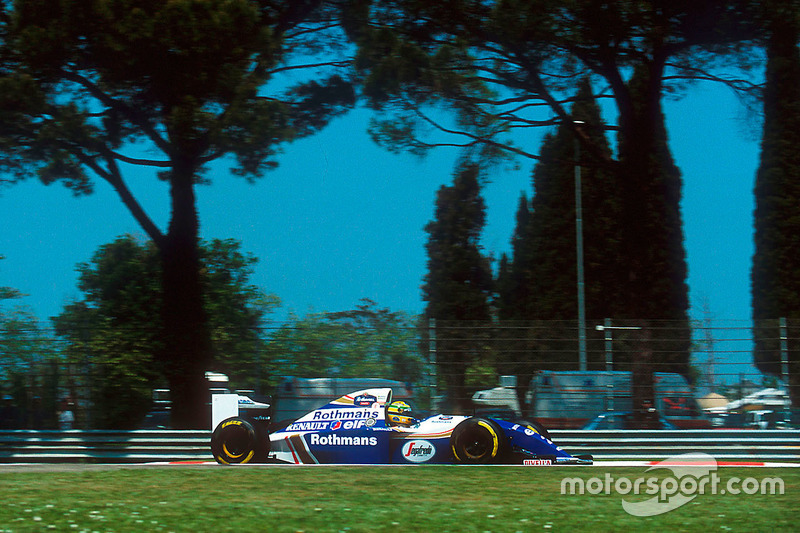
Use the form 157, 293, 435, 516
751, 2, 800, 405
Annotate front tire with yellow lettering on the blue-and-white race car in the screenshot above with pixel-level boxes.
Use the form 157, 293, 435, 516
450, 418, 508, 464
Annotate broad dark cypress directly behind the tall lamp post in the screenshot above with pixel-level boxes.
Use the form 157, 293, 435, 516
499, 80, 621, 370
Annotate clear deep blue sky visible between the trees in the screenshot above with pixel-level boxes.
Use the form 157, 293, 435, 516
0, 79, 760, 378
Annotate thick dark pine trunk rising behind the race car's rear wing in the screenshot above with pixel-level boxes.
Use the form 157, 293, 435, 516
161, 159, 211, 429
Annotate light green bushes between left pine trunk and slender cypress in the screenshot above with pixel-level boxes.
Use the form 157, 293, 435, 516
269, 299, 423, 383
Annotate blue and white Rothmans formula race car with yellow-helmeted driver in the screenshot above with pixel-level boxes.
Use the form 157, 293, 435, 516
211, 389, 592, 466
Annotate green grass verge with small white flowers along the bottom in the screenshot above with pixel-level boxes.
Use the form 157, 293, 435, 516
0, 466, 800, 533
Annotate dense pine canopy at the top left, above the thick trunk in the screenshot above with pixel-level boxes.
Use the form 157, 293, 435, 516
0, 0, 354, 186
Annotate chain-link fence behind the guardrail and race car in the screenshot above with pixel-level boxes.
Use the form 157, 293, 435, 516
0, 319, 800, 429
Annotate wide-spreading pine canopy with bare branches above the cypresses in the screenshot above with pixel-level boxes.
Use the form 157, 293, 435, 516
356, 0, 763, 162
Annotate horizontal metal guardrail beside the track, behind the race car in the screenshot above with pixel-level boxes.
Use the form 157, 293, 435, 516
0, 430, 800, 463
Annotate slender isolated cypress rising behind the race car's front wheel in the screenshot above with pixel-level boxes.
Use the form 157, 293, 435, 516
423, 163, 492, 412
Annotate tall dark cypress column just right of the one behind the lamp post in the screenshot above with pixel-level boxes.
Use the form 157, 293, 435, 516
619, 59, 690, 404
